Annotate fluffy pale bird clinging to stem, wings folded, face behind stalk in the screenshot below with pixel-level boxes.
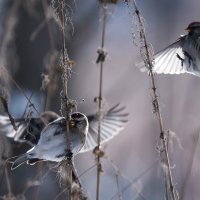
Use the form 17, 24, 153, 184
12, 112, 89, 169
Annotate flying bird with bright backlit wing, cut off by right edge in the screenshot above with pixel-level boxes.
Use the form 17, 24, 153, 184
138, 22, 200, 76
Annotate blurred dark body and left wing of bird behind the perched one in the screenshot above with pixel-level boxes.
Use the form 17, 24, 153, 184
0, 111, 60, 146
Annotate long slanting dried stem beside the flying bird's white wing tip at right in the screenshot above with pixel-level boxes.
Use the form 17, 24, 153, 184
130, 0, 177, 200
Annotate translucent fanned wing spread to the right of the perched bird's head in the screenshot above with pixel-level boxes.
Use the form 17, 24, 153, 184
80, 104, 128, 153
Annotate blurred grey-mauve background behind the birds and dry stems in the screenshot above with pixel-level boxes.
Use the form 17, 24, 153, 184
0, 0, 200, 200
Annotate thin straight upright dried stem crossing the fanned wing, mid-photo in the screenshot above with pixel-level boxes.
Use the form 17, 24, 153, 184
96, 3, 106, 200
